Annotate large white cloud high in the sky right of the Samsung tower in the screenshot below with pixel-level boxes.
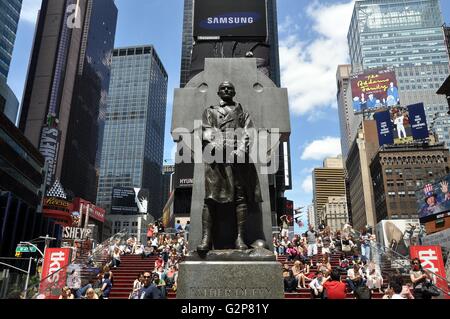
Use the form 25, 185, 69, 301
280, 0, 354, 119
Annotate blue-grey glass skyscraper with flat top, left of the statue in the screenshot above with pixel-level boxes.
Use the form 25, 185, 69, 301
97, 45, 168, 219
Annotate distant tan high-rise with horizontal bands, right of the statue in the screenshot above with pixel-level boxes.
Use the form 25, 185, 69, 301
313, 157, 346, 228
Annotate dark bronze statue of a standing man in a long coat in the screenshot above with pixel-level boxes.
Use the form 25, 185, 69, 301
197, 82, 262, 253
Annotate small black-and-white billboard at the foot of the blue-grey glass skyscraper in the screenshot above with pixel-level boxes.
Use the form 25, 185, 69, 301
111, 187, 149, 215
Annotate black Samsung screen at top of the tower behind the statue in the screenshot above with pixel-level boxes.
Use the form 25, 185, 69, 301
194, 0, 267, 40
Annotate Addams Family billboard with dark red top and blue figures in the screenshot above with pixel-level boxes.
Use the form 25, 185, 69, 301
350, 69, 400, 113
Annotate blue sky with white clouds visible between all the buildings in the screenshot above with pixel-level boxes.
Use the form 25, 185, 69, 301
8, 0, 450, 215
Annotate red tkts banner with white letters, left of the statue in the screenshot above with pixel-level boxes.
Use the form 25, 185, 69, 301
39, 248, 71, 299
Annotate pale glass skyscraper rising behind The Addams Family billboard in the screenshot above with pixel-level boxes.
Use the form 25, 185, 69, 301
348, 0, 450, 146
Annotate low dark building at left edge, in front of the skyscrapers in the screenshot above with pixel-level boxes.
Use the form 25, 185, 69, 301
0, 113, 61, 257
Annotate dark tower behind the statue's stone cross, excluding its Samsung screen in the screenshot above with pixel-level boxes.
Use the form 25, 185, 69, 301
174, 0, 292, 230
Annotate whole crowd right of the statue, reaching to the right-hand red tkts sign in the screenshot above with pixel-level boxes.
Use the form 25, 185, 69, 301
282, 224, 439, 299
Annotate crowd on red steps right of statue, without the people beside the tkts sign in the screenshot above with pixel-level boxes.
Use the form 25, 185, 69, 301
282, 224, 383, 299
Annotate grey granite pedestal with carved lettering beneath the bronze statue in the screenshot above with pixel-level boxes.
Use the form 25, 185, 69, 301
177, 261, 284, 299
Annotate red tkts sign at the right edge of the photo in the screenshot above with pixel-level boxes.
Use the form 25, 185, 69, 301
410, 246, 448, 298
